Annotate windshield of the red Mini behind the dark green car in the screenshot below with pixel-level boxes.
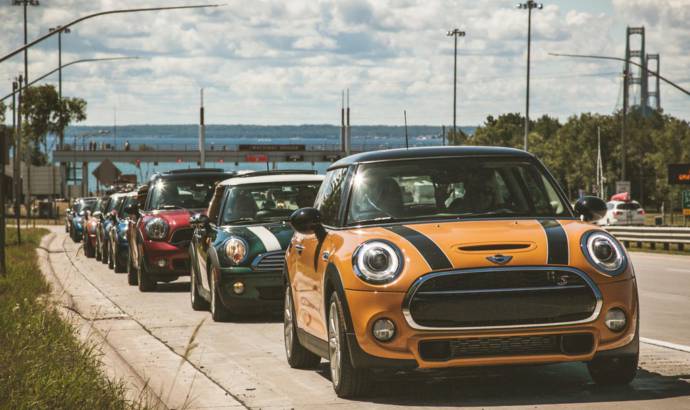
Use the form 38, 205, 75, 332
147, 174, 227, 210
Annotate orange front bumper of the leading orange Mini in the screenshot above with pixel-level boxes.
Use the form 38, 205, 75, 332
345, 279, 638, 368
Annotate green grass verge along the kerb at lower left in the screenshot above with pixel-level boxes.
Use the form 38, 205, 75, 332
0, 229, 142, 409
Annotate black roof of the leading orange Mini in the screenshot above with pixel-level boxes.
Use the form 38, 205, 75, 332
328, 145, 534, 170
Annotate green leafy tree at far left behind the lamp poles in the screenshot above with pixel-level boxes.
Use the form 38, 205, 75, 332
21, 84, 86, 165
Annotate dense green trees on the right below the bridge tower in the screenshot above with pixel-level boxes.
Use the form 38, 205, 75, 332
449, 111, 690, 210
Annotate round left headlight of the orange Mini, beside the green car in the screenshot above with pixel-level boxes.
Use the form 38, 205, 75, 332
352, 240, 403, 284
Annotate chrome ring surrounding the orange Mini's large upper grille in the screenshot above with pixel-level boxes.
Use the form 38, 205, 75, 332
402, 266, 603, 331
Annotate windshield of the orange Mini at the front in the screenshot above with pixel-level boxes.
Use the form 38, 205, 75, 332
348, 158, 571, 224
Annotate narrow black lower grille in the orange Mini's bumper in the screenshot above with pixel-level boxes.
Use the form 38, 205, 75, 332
419, 333, 594, 361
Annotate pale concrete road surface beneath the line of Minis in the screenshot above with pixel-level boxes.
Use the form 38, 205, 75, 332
41, 228, 690, 409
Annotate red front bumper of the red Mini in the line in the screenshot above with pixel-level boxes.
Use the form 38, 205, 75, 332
143, 241, 190, 279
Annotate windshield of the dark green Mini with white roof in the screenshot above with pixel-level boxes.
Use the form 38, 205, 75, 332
221, 182, 321, 224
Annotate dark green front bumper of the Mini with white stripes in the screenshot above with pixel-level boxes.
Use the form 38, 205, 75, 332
218, 268, 285, 312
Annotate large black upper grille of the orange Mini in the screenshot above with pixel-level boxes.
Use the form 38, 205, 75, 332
405, 268, 599, 328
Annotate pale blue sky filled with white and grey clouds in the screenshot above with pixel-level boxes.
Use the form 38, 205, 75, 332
0, 0, 690, 125
